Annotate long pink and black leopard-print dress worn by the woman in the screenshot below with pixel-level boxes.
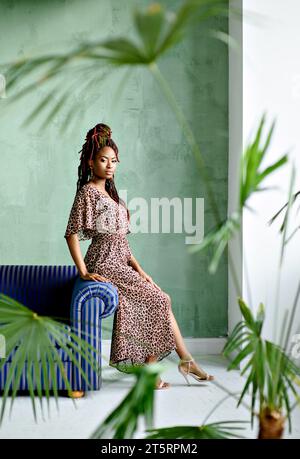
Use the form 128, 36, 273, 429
64, 183, 176, 373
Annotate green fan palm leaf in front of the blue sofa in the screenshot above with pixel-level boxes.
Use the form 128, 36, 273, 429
0, 293, 100, 423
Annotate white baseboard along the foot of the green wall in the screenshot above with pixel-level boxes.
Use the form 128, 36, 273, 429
102, 338, 226, 355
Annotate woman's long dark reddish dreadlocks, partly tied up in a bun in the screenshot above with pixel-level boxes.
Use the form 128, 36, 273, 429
77, 123, 130, 220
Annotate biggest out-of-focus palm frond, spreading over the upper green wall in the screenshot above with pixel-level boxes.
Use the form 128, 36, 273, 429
0, 0, 232, 133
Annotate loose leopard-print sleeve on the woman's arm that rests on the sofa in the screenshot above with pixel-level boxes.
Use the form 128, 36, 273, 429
64, 187, 97, 241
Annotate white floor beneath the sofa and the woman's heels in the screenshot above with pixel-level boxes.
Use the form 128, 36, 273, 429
0, 353, 300, 439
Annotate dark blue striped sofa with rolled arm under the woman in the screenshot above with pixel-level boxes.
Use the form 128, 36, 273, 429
0, 265, 118, 391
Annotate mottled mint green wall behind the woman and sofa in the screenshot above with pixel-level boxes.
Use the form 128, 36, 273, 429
0, 0, 228, 338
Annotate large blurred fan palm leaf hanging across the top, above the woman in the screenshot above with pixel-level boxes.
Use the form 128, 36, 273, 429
0, 0, 230, 132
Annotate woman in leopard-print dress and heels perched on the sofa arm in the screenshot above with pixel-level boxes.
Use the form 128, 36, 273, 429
64, 123, 213, 397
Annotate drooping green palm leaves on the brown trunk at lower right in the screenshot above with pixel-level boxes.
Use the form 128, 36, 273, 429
223, 298, 300, 434
